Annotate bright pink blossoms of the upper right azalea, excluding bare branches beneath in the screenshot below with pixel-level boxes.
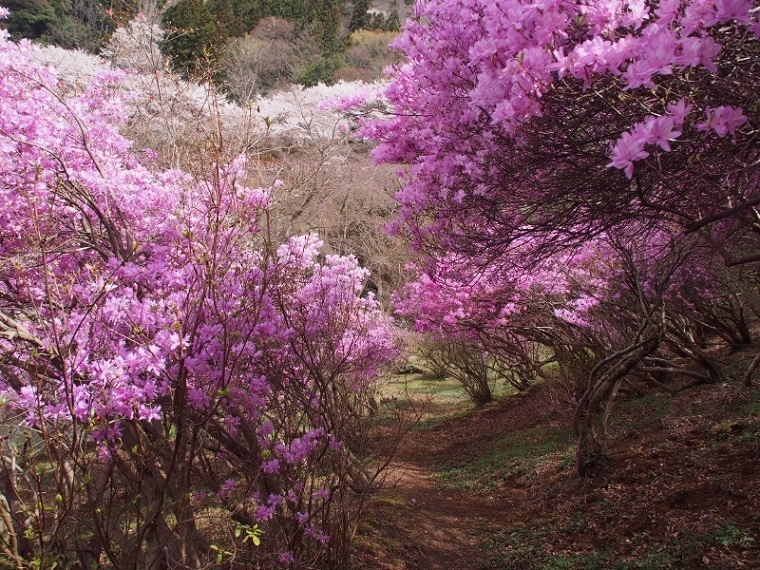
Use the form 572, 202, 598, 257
362, 0, 760, 247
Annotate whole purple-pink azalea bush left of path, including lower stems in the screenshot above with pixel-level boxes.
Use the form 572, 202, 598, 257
0, 11, 396, 567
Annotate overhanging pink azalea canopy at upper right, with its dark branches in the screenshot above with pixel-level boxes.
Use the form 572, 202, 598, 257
364, 0, 760, 260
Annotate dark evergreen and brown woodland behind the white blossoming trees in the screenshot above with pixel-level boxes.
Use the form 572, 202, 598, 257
6, 0, 409, 89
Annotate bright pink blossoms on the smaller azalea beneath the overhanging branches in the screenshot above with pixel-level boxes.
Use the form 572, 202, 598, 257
394, 242, 607, 362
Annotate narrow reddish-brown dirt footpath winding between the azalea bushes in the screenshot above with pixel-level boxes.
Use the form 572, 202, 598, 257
362, 400, 536, 570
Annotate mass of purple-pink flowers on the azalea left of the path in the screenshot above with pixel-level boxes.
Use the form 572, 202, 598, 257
0, 14, 397, 563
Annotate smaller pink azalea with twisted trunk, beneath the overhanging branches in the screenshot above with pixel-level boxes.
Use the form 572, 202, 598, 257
395, 221, 758, 471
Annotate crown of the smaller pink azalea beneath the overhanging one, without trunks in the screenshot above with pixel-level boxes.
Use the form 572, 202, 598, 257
394, 222, 735, 382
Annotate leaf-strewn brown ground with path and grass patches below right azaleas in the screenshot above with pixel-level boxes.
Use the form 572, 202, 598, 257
355, 358, 760, 570
